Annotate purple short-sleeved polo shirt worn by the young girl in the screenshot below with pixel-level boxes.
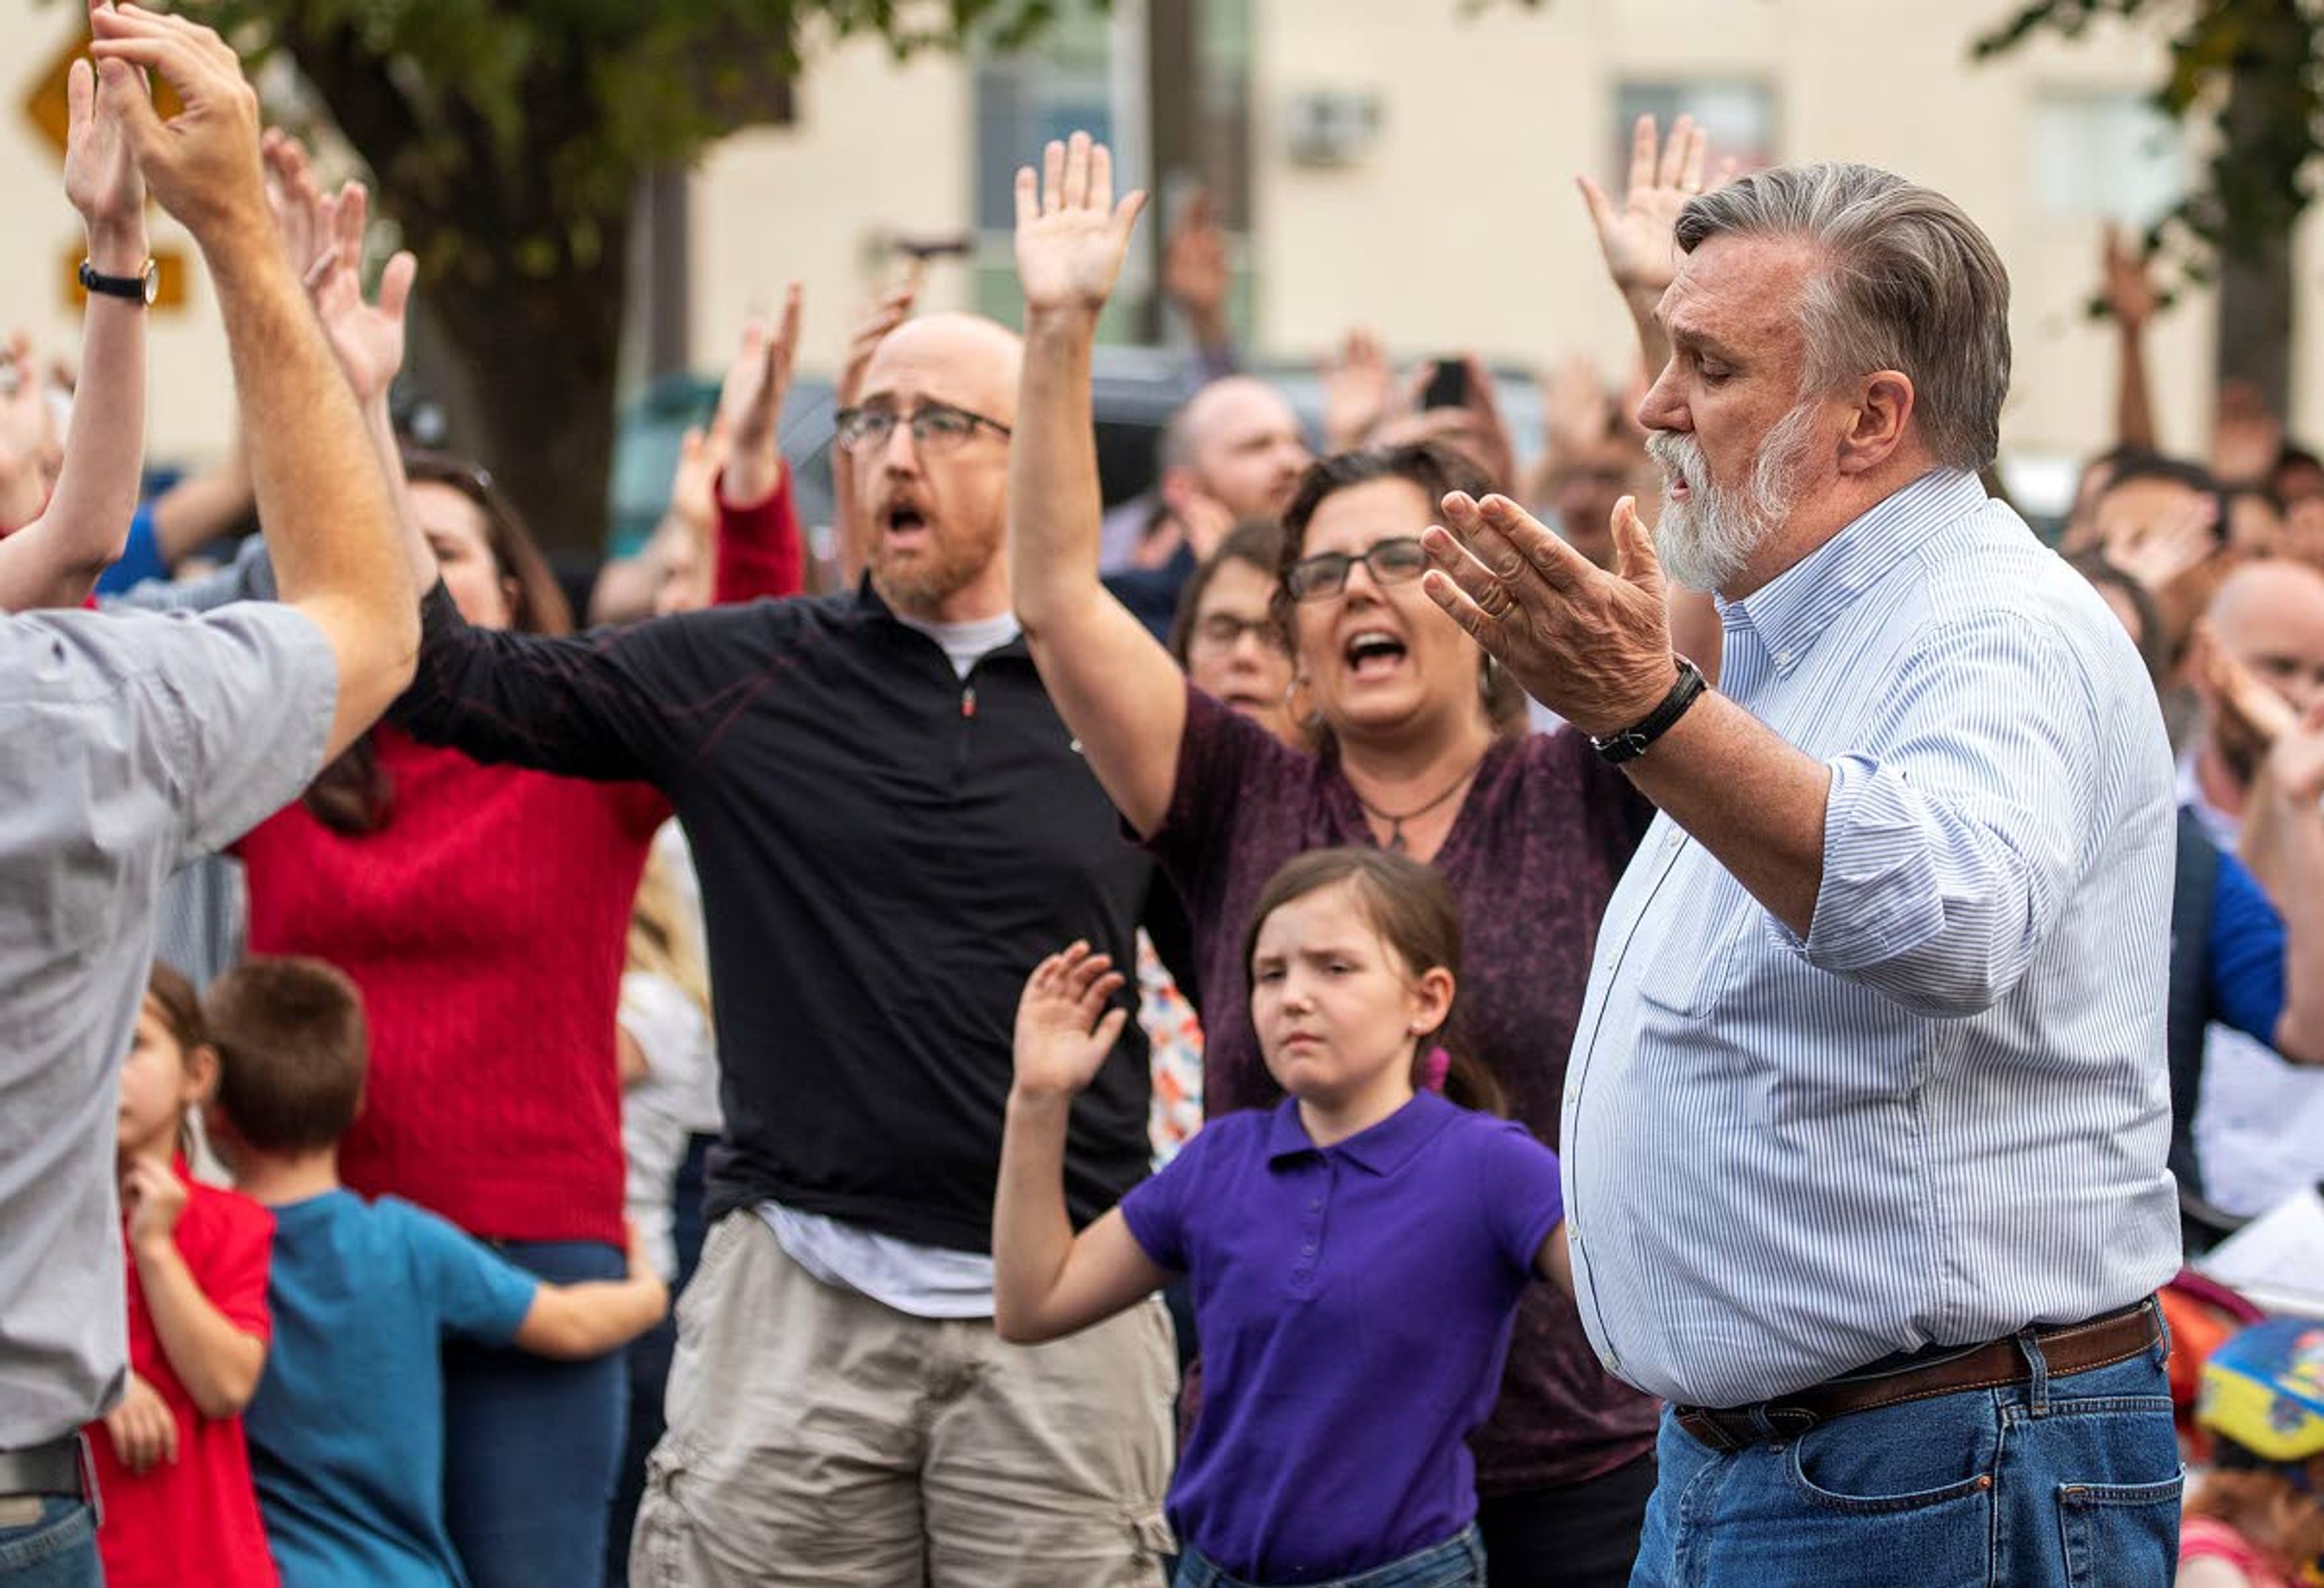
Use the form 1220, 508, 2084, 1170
1123, 1093, 1564, 1583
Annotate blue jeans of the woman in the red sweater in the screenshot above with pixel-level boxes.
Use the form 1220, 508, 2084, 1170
444, 1242, 630, 1588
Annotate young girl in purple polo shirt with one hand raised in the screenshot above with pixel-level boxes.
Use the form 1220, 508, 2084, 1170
993, 848, 1574, 1588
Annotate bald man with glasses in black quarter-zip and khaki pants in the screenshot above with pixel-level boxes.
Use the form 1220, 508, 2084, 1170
398, 314, 1176, 1588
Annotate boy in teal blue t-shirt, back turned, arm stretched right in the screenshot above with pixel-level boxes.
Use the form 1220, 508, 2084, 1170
207, 958, 669, 1588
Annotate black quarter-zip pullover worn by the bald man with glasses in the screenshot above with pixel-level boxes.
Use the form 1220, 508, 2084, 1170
393, 583, 1153, 1251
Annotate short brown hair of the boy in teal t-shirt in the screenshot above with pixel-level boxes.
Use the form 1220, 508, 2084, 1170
205, 956, 370, 1153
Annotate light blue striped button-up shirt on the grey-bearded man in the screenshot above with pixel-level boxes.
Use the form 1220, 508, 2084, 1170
1564, 470, 2180, 1406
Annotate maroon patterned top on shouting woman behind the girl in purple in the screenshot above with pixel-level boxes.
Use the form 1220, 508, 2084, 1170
1148, 684, 1657, 1495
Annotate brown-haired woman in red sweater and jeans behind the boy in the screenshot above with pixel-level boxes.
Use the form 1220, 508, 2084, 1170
235, 453, 797, 1588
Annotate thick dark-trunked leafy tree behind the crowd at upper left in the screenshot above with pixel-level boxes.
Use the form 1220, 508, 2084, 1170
143, 0, 1060, 549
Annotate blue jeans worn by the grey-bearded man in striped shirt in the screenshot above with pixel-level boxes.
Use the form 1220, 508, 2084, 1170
1629, 1344, 2185, 1588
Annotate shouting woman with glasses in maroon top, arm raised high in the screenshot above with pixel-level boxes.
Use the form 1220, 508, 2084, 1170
1009, 135, 1657, 1583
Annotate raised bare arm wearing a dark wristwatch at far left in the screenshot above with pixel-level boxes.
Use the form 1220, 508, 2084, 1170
0, 48, 146, 611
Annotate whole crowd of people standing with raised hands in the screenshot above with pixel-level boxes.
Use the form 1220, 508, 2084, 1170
13, 2, 2324, 1588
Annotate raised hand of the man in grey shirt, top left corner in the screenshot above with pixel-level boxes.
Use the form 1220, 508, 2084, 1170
88, 2, 268, 251
